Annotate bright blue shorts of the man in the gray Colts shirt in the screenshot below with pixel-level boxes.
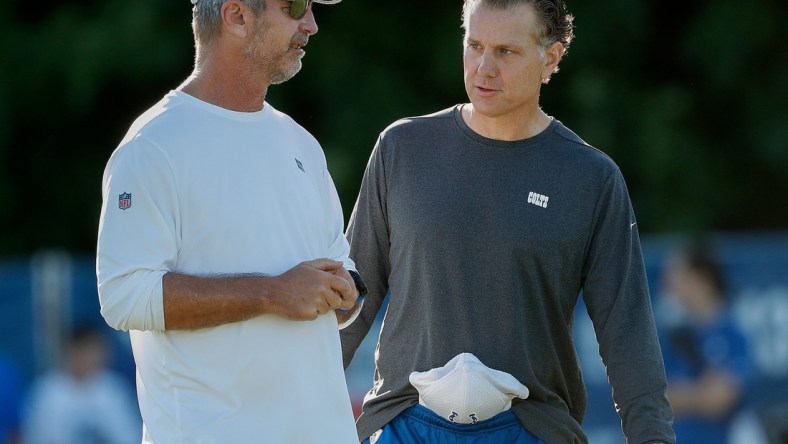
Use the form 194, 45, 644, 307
362, 404, 545, 444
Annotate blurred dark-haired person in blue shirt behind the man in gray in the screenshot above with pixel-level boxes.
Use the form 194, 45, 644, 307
660, 241, 749, 444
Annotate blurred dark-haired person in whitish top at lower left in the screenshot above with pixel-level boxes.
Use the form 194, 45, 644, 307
22, 325, 142, 444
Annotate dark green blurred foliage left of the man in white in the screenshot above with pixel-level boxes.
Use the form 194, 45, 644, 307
0, 0, 192, 253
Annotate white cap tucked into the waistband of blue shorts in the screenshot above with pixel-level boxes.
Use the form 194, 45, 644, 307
409, 353, 528, 424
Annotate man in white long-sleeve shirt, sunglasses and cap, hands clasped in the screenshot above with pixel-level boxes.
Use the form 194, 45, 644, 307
97, 0, 363, 444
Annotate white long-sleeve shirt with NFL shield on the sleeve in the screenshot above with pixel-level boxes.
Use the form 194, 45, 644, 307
97, 92, 356, 444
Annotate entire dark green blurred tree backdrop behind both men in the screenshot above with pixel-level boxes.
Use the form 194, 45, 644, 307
0, 0, 788, 255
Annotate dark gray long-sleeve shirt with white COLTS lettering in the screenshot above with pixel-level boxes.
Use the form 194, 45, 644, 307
341, 106, 674, 444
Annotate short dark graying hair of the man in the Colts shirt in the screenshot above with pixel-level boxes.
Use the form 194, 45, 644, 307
462, 0, 574, 57
